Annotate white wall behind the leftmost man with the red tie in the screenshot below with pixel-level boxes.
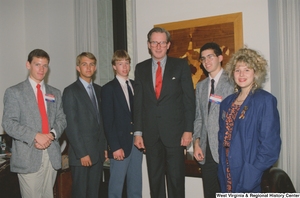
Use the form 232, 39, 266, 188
0, 0, 76, 134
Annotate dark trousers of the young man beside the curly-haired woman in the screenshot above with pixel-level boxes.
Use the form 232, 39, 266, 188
200, 140, 221, 198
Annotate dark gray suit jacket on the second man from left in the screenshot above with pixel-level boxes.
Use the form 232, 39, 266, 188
63, 79, 107, 166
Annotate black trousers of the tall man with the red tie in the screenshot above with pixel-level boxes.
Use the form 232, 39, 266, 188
146, 141, 185, 198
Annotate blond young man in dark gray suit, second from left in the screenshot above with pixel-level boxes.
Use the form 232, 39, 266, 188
63, 52, 106, 198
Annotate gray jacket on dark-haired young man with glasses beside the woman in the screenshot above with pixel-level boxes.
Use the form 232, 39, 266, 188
193, 71, 233, 164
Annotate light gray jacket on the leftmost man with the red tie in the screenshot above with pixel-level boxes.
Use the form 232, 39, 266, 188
2, 79, 67, 173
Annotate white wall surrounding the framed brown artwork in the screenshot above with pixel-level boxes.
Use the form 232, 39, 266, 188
135, 0, 270, 198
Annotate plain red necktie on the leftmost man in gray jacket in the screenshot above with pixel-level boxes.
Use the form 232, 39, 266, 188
36, 84, 49, 134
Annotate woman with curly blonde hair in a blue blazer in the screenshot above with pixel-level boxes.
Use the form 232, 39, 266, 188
218, 47, 281, 192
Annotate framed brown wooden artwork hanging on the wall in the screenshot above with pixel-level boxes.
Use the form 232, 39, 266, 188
154, 12, 243, 88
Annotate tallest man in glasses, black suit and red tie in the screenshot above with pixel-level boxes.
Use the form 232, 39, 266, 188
134, 27, 195, 198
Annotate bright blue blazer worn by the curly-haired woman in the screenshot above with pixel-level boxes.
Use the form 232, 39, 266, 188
218, 89, 281, 192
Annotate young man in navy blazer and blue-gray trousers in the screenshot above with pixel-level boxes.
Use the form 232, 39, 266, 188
101, 50, 143, 198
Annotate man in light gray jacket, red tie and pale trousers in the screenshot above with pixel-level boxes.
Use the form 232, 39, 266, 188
2, 49, 66, 198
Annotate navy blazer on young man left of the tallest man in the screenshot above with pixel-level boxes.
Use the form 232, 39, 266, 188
101, 78, 133, 158
